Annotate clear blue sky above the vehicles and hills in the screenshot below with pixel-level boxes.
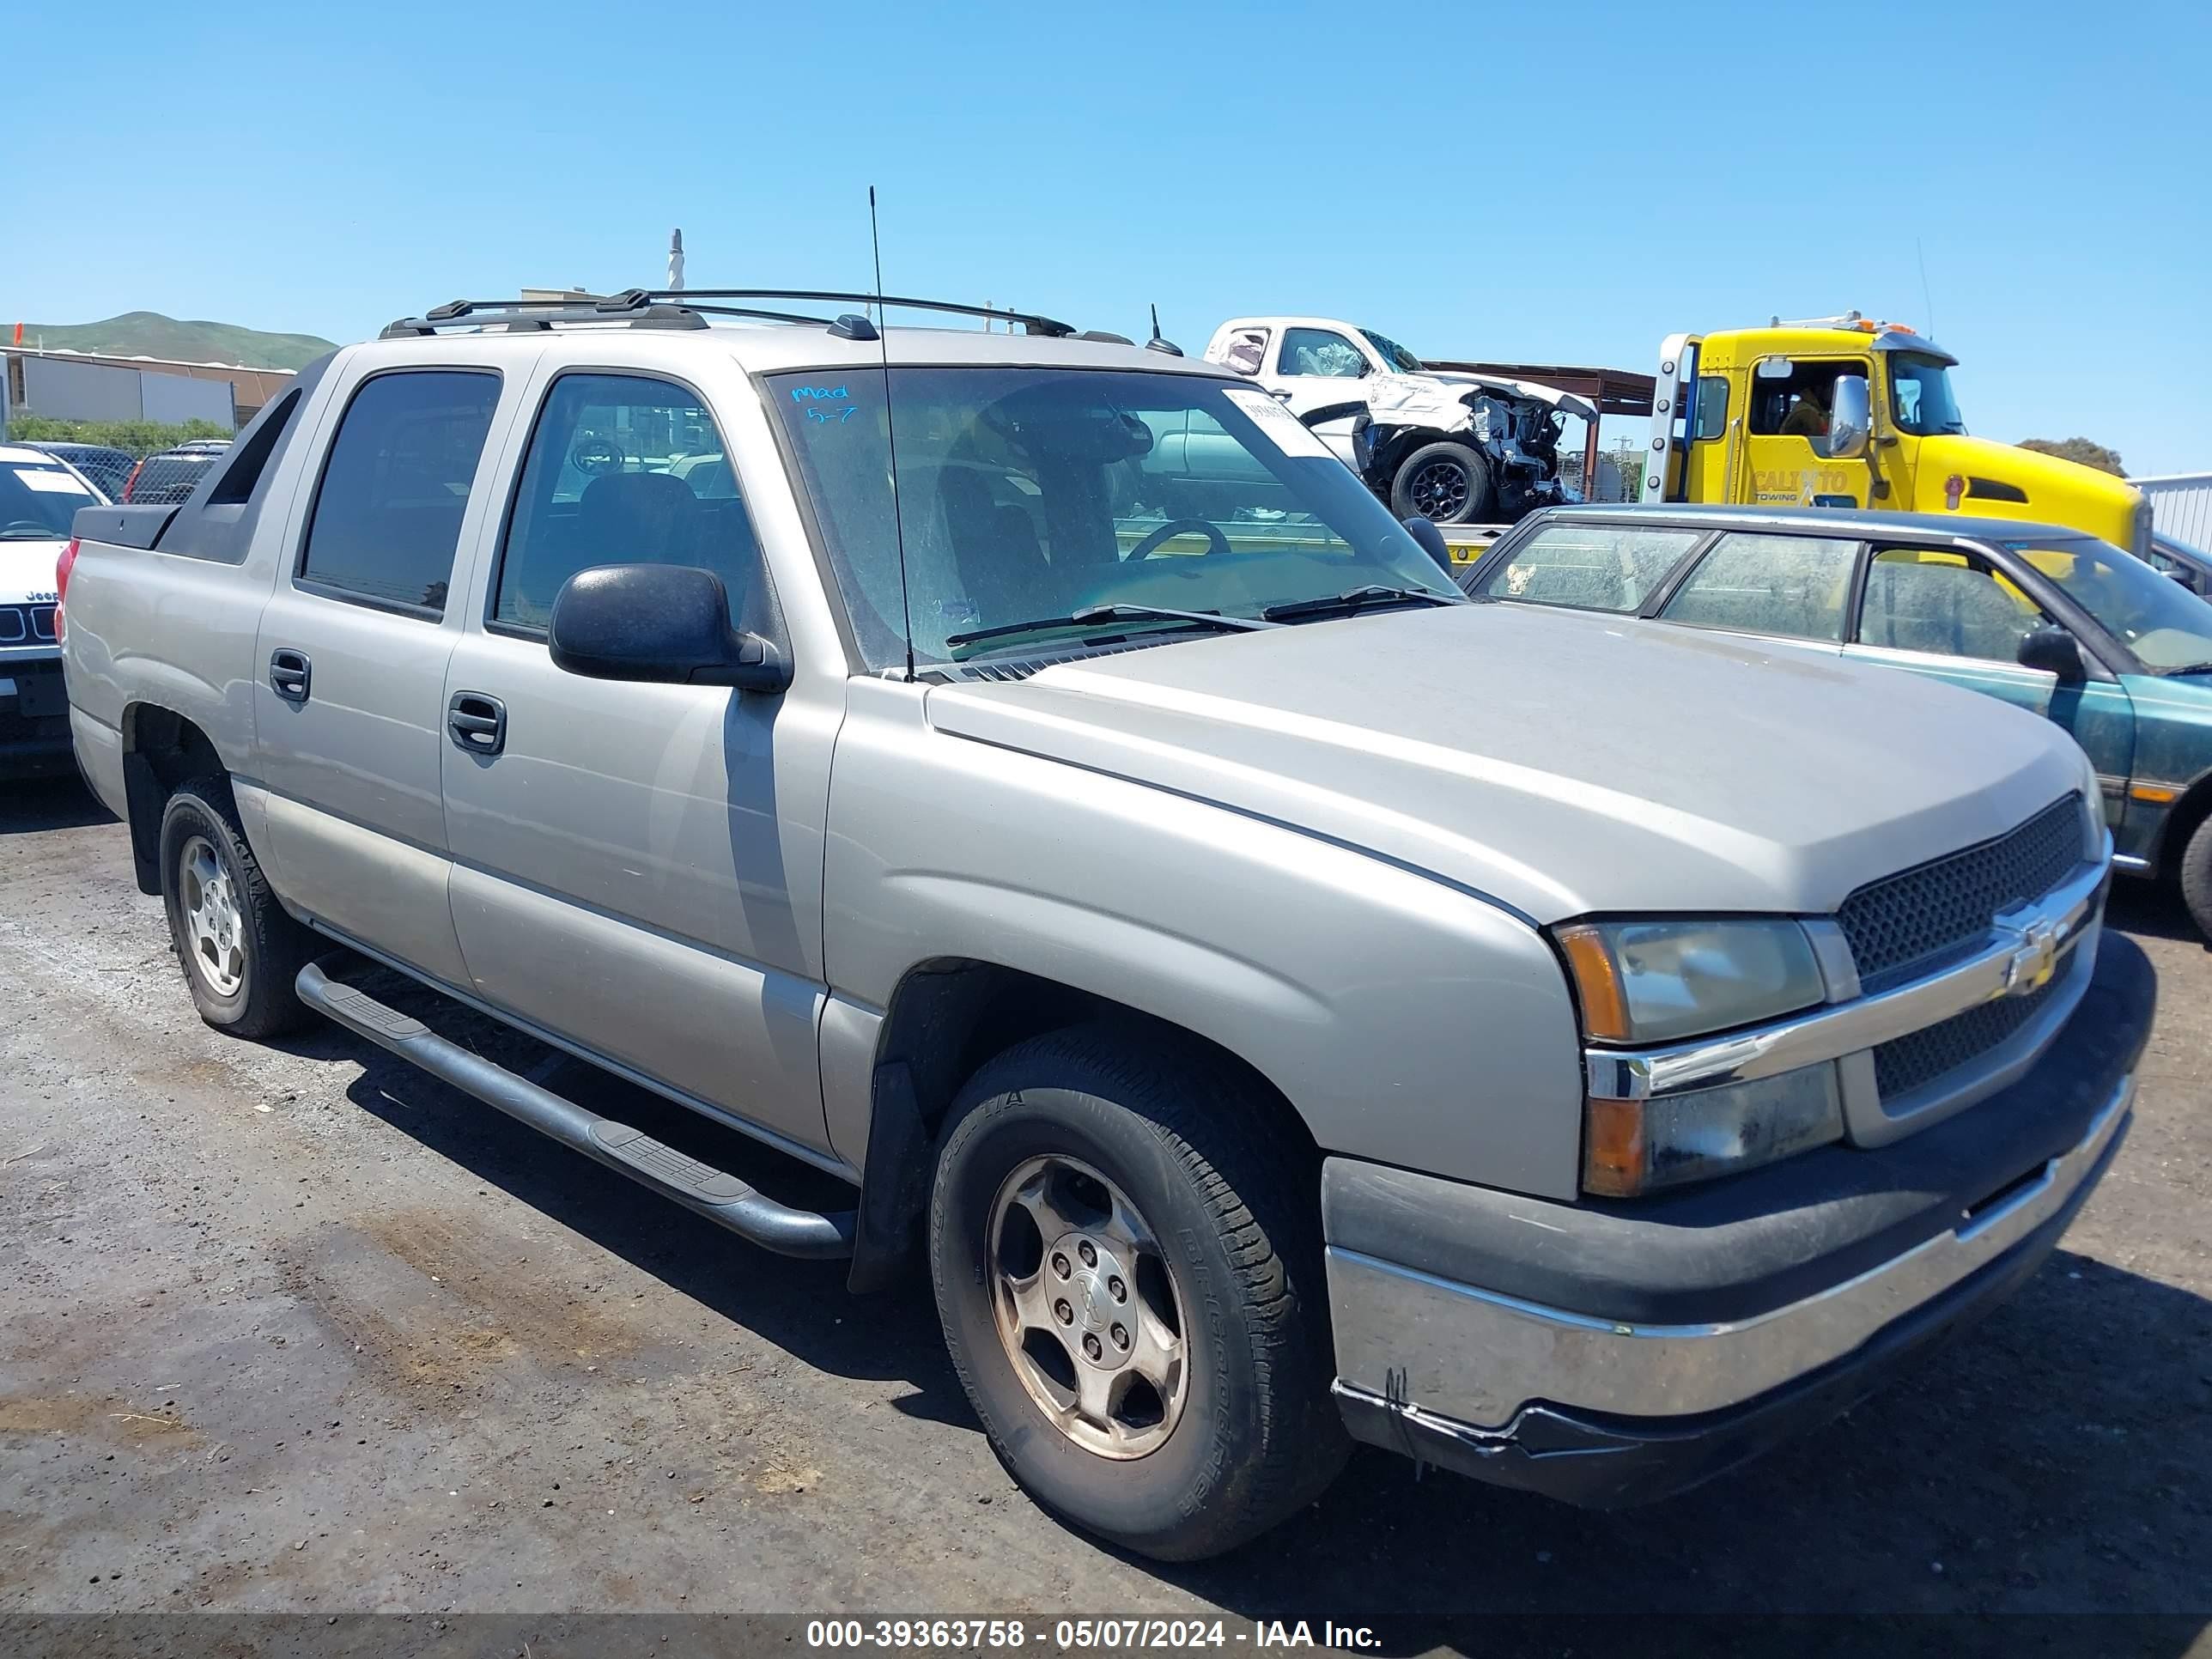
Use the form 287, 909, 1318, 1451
13, 0, 2212, 473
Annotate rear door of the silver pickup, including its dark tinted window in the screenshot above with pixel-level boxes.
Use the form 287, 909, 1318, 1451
254, 360, 520, 984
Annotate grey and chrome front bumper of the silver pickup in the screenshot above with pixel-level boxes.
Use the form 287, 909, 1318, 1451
1322, 936, 2157, 1506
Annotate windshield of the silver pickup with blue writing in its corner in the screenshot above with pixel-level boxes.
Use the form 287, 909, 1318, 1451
768, 368, 1460, 671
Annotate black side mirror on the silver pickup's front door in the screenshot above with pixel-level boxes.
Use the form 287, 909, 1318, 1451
546, 564, 792, 692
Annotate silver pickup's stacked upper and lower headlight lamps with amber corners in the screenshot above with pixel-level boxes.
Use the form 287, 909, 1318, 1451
1558, 921, 1843, 1197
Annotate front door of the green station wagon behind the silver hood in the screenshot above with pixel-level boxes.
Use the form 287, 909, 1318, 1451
1844, 546, 2135, 825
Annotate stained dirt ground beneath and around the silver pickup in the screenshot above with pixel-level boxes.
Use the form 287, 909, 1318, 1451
0, 783, 2212, 1648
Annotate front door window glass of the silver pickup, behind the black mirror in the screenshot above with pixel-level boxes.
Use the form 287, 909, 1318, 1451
491, 374, 775, 633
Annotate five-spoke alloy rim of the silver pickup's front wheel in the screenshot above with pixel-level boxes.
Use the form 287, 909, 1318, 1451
988, 1155, 1190, 1460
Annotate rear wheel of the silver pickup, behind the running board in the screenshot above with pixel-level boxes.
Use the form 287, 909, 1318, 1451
161, 776, 310, 1037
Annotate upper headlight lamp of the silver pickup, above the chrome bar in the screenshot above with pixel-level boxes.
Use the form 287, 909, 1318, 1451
1558, 921, 1827, 1042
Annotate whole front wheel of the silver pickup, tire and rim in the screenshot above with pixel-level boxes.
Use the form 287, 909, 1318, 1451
929, 1026, 1347, 1559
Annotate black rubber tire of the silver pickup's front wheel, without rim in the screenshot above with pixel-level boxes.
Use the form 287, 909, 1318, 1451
929, 1024, 1349, 1562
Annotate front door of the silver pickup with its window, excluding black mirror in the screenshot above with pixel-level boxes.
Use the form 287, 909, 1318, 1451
441, 372, 827, 1152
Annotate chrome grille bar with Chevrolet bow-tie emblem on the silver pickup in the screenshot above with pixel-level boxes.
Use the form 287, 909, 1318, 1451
1583, 858, 2108, 1099
